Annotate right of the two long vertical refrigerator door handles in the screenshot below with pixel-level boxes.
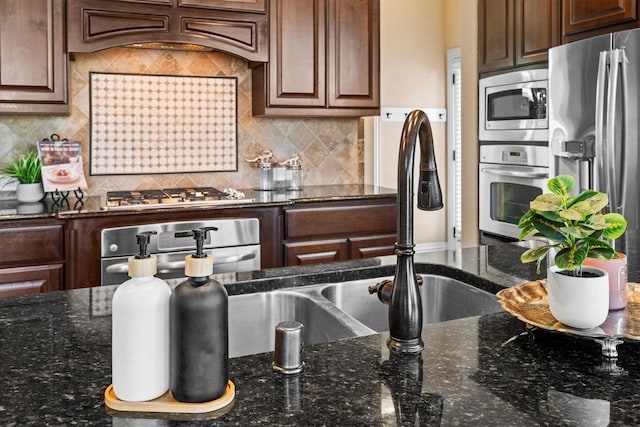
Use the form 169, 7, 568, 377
600, 49, 620, 212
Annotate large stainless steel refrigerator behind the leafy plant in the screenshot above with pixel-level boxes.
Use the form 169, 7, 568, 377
548, 29, 640, 230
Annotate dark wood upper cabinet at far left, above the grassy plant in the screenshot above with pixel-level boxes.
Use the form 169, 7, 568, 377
0, 0, 69, 114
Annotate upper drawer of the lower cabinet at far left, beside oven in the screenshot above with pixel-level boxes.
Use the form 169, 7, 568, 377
0, 225, 64, 267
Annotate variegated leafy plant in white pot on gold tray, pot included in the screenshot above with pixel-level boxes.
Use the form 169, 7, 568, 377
518, 175, 627, 329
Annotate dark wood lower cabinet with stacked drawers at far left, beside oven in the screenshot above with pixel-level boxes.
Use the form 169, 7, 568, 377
0, 220, 65, 297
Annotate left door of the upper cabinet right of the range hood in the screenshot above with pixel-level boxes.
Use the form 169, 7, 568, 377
267, 0, 326, 107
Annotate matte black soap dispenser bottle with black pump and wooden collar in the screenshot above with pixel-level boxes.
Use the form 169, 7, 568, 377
170, 227, 229, 403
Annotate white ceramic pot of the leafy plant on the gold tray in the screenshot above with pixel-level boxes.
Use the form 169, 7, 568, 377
547, 266, 609, 329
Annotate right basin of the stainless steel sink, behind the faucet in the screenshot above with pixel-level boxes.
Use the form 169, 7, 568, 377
322, 274, 502, 332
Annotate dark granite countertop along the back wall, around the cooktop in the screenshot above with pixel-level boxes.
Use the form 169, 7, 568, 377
0, 184, 396, 220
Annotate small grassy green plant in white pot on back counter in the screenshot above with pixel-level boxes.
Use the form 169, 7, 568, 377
0, 150, 44, 203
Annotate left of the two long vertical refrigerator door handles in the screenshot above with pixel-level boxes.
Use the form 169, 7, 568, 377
596, 51, 609, 191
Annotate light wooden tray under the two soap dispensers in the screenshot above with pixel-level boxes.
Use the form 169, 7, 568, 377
104, 380, 236, 415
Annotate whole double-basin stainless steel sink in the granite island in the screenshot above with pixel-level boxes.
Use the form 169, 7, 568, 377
229, 274, 501, 357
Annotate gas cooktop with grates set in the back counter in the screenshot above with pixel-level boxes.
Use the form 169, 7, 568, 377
102, 187, 253, 210
